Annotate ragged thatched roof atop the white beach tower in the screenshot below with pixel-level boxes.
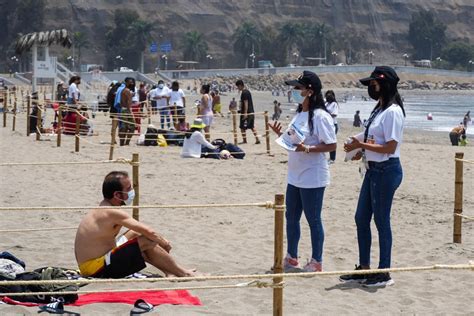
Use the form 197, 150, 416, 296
15, 29, 72, 55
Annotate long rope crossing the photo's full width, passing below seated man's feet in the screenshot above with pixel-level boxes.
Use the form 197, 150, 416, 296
0, 261, 474, 288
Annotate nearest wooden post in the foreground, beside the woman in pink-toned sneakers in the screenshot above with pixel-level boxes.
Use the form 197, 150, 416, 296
273, 194, 285, 316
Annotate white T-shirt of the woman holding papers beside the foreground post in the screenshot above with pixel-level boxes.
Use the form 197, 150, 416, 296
288, 109, 337, 189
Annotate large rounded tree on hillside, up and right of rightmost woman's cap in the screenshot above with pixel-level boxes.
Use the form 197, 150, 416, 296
408, 10, 446, 60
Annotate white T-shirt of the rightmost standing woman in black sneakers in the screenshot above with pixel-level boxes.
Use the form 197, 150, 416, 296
365, 104, 405, 162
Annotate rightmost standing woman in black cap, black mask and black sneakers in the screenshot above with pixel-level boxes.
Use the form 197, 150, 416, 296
340, 66, 405, 287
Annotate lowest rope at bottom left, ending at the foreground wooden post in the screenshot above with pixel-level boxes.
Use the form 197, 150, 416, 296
1, 280, 284, 296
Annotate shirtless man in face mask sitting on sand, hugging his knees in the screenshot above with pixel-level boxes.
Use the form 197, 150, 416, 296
74, 171, 196, 278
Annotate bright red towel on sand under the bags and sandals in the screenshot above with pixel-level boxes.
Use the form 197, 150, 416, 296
2, 290, 202, 306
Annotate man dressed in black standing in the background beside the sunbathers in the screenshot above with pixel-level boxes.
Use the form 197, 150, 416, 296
235, 79, 260, 144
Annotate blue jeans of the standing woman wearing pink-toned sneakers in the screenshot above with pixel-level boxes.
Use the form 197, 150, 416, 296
286, 184, 325, 262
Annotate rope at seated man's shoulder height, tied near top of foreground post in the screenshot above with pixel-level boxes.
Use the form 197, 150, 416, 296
0, 201, 274, 211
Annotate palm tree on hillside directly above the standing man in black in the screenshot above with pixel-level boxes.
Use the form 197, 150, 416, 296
233, 22, 262, 68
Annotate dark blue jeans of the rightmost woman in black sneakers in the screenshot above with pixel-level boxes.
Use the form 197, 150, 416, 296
355, 158, 403, 269
